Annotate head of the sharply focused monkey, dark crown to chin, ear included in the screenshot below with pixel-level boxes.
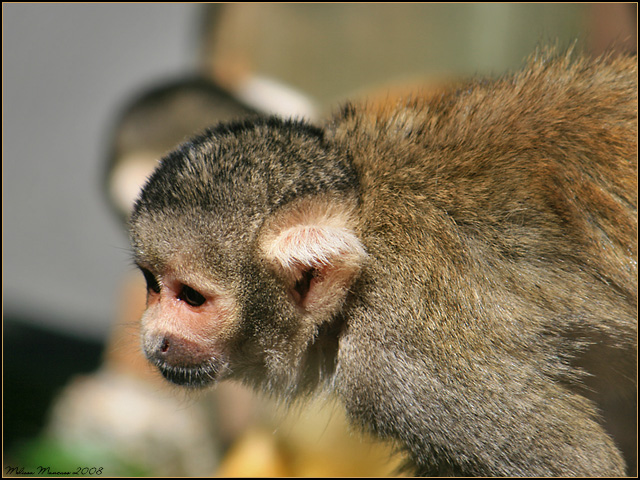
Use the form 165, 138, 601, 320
130, 118, 366, 393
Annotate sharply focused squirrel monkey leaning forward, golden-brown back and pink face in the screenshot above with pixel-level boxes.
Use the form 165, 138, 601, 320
130, 53, 638, 476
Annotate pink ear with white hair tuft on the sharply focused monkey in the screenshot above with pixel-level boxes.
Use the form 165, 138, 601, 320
262, 200, 366, 318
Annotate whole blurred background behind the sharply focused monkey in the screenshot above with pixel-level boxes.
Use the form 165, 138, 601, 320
2, 3, 637, 475
